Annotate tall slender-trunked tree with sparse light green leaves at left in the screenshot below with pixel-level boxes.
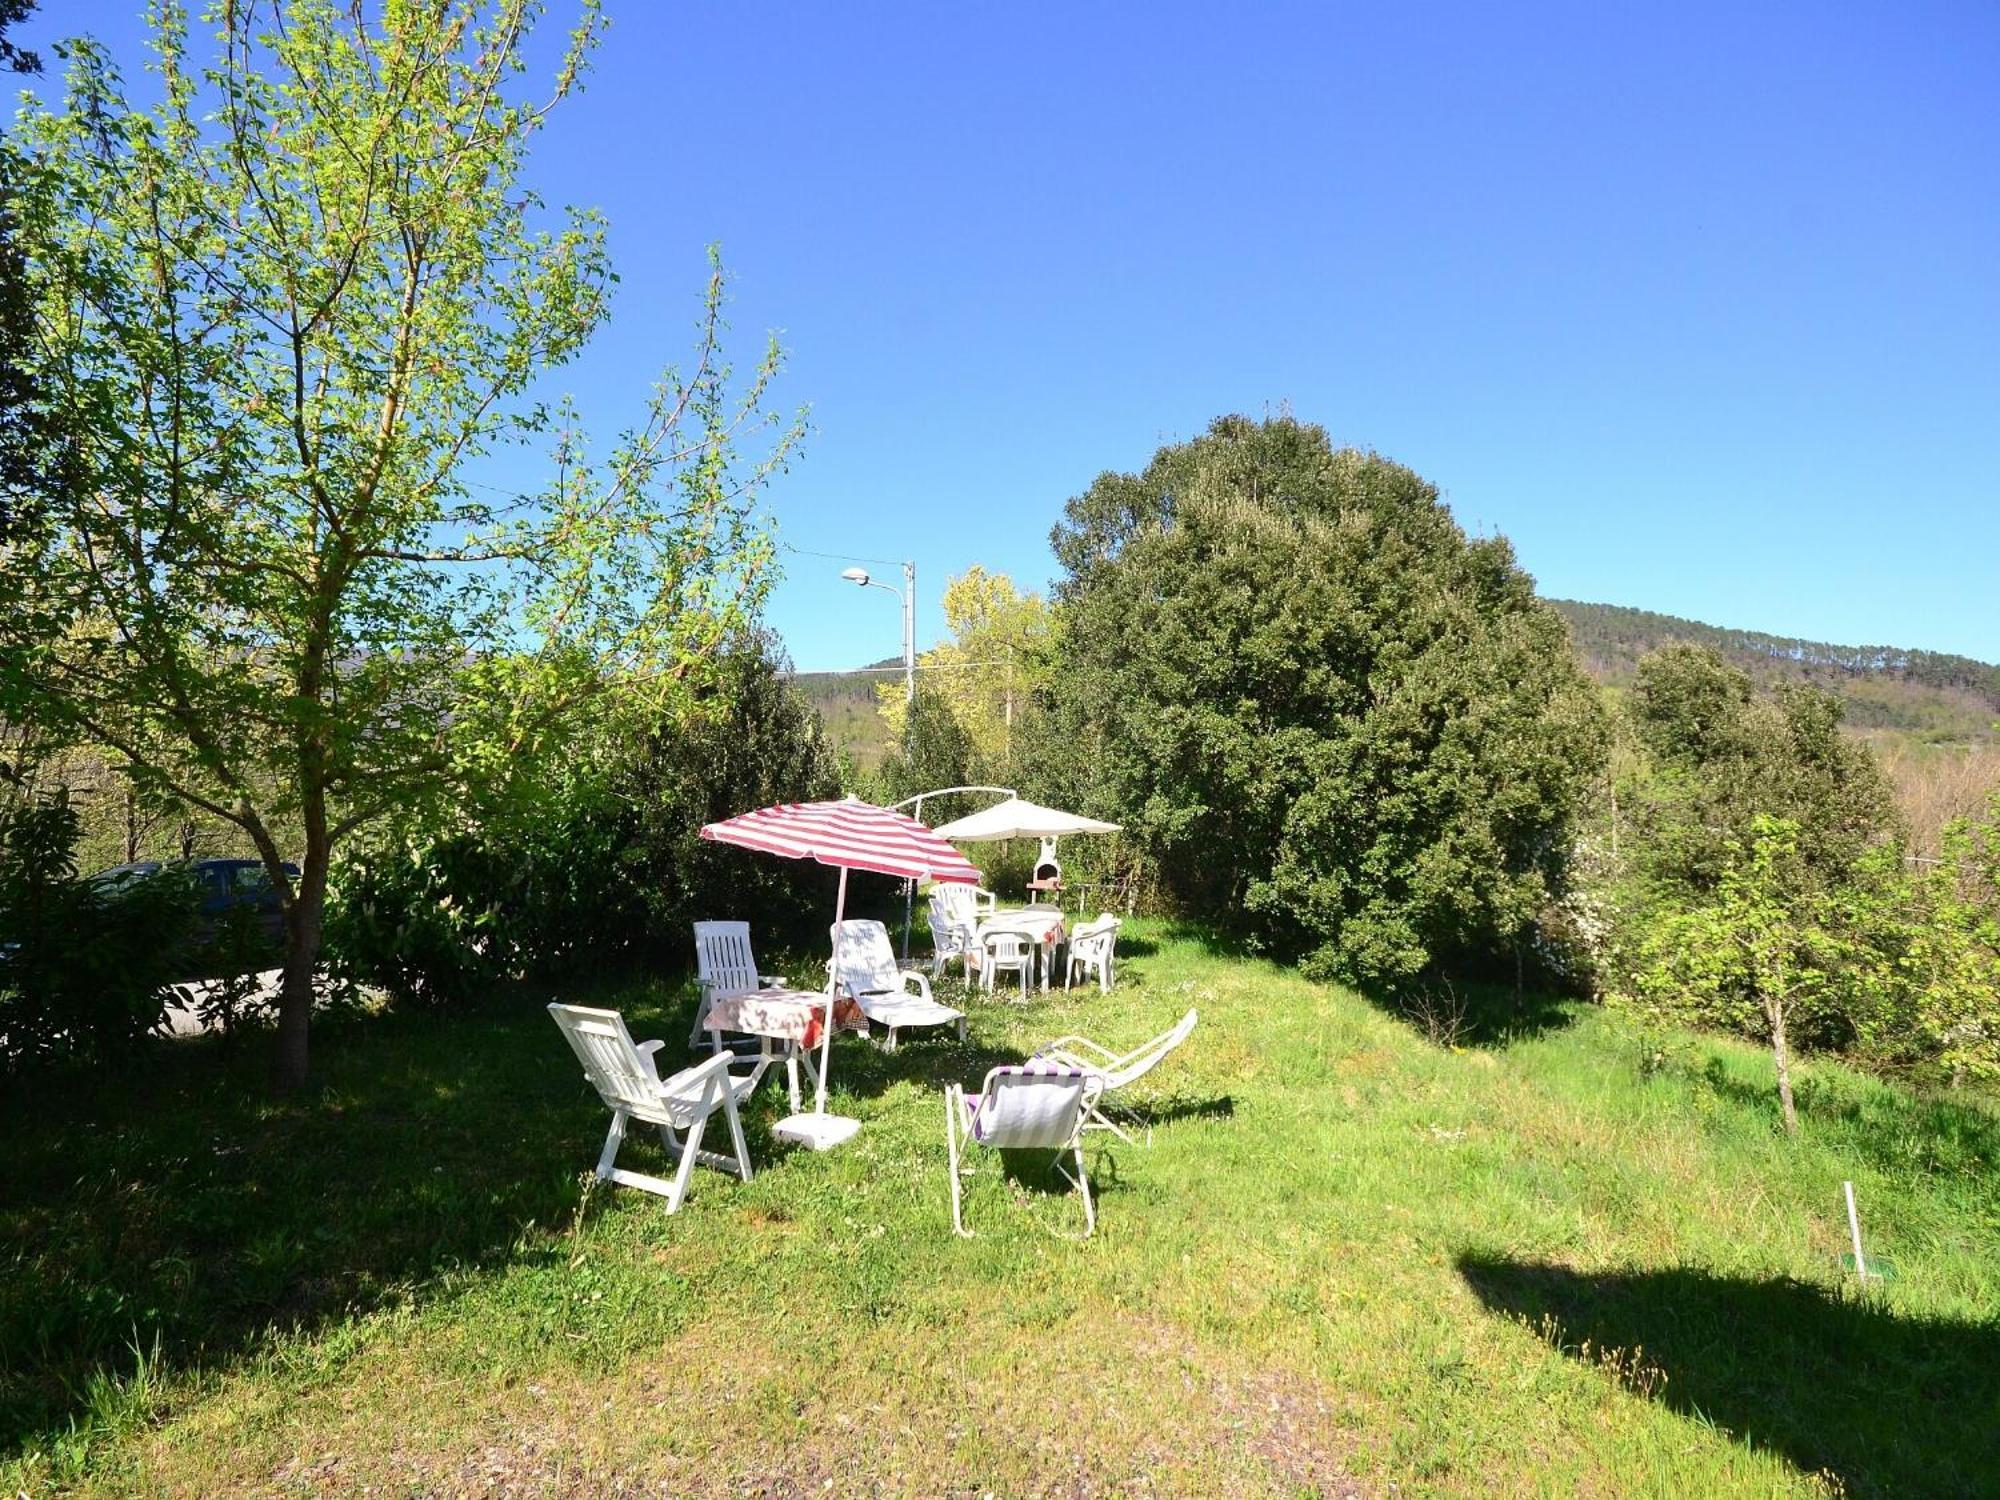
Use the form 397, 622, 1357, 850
0, 0, 796, 1086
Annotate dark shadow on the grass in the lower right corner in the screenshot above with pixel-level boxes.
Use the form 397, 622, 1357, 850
1458, 1254, 2000, 1496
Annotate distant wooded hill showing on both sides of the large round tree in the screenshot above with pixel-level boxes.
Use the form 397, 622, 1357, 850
798, 598, 2000, 770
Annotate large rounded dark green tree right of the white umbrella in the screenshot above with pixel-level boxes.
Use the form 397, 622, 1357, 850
1032, 416, 1604, 982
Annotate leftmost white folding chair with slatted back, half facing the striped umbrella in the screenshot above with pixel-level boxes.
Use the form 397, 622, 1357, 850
548, 1004, 756, 1214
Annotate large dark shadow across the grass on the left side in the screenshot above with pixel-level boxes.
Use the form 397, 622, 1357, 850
0, 988, 760, 1456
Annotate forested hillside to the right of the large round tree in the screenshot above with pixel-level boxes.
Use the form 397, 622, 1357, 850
1550, 598, 2000, 740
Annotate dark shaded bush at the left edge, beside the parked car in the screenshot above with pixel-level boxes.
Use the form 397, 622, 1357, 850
0, 794, 200, 1070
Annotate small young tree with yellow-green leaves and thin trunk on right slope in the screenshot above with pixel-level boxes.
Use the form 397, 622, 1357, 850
1636, 814, 1860, 1132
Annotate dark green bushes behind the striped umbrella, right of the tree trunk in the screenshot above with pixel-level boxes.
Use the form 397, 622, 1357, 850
326, 642, 838, 1006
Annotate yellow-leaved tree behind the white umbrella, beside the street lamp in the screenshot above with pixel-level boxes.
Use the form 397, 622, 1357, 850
876, 564, 1054, 776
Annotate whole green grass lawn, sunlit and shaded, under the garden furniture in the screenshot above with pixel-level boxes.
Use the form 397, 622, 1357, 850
0, 924, 2000, 1496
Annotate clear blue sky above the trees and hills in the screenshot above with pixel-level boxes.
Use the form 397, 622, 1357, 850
22, 0, 2000, 670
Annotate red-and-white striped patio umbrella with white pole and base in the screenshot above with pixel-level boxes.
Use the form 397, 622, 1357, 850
702, 796, 980, 1150
